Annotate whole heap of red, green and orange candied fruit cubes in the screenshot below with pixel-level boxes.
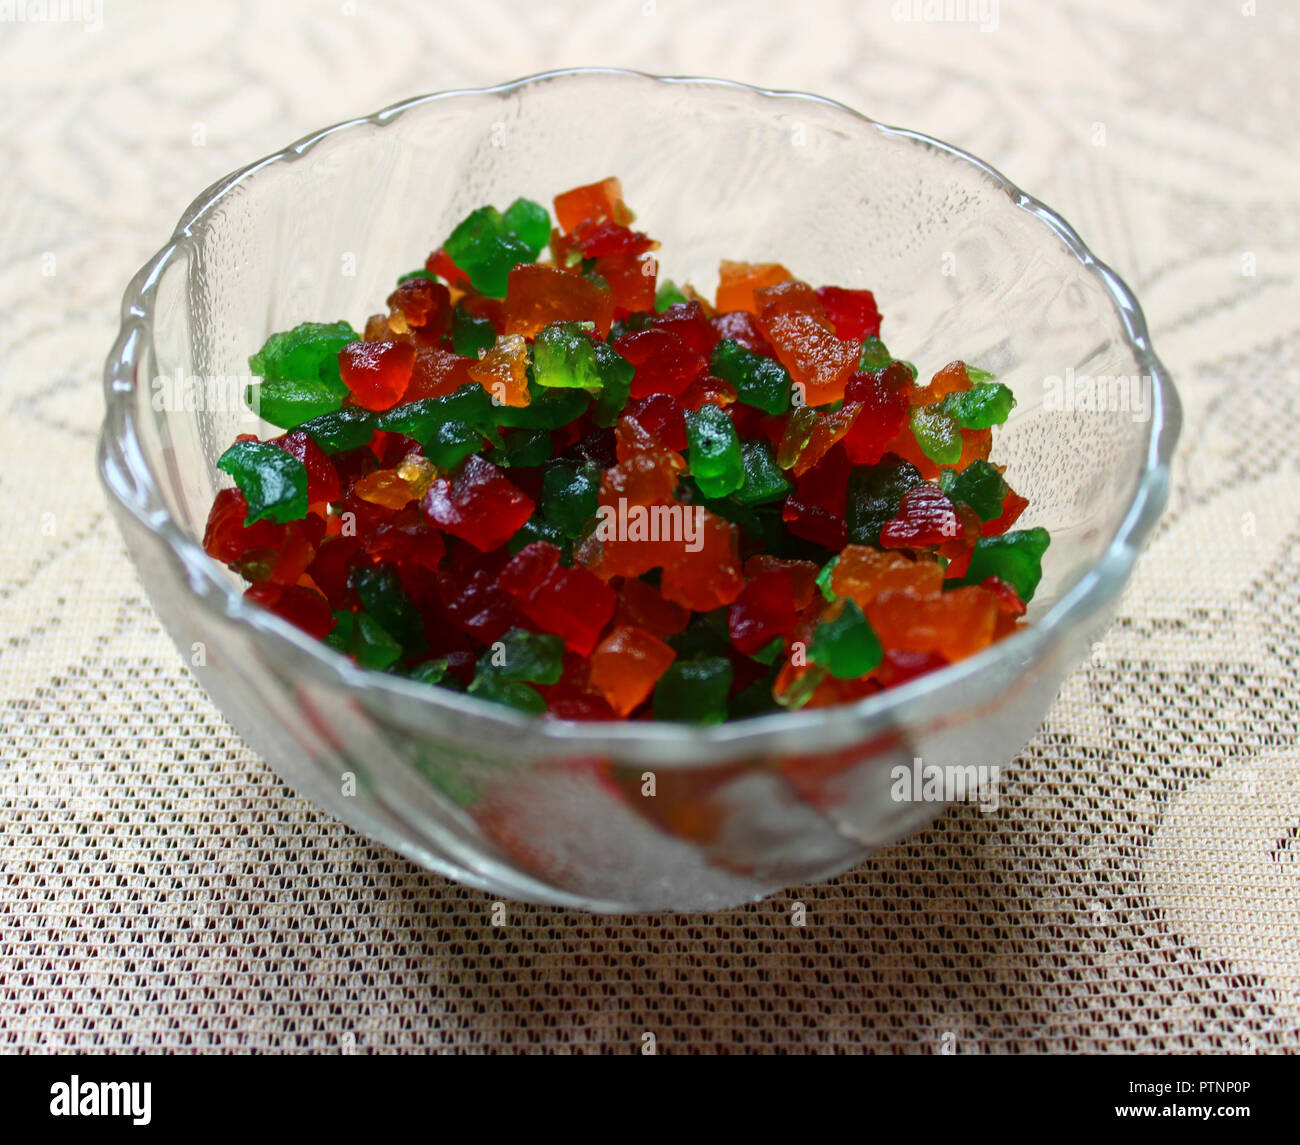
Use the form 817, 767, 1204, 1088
204, 178, 1049, 725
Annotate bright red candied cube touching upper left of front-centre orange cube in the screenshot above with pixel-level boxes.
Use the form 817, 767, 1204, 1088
501, 541, 618, 656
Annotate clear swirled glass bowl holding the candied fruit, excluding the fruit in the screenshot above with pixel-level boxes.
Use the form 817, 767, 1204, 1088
99, 69, 1180, 911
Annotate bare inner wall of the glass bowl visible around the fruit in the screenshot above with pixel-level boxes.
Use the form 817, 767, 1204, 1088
126, 71, 1153, 717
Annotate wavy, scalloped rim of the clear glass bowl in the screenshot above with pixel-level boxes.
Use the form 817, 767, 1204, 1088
98, 68, 1182, 767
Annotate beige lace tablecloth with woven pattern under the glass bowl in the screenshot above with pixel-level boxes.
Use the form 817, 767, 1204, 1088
0, 0, 1300, 1053
